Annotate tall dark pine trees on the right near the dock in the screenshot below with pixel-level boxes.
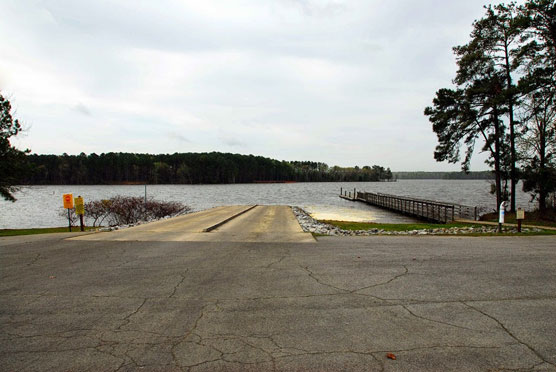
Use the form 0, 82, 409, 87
425, 0, 556, 211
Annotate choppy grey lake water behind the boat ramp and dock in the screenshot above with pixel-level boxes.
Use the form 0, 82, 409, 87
0, 180, 534, 229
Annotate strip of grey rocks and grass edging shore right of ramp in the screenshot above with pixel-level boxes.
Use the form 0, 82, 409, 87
292, 207, 542, 236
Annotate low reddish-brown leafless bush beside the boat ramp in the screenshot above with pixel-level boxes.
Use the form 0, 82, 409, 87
81, 196, 190, 226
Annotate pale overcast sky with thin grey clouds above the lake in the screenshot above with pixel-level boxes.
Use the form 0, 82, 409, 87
0, 0, 512, 171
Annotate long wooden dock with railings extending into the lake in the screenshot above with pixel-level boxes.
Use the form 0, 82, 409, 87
340, 189, 482, 223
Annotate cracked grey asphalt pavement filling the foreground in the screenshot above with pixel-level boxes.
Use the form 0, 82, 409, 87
0, 217, 556, 372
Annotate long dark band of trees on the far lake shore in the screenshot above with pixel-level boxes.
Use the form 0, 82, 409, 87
22, 152, 392, 185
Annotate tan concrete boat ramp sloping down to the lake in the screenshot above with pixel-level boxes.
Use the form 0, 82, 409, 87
74, 205, 315, 243
